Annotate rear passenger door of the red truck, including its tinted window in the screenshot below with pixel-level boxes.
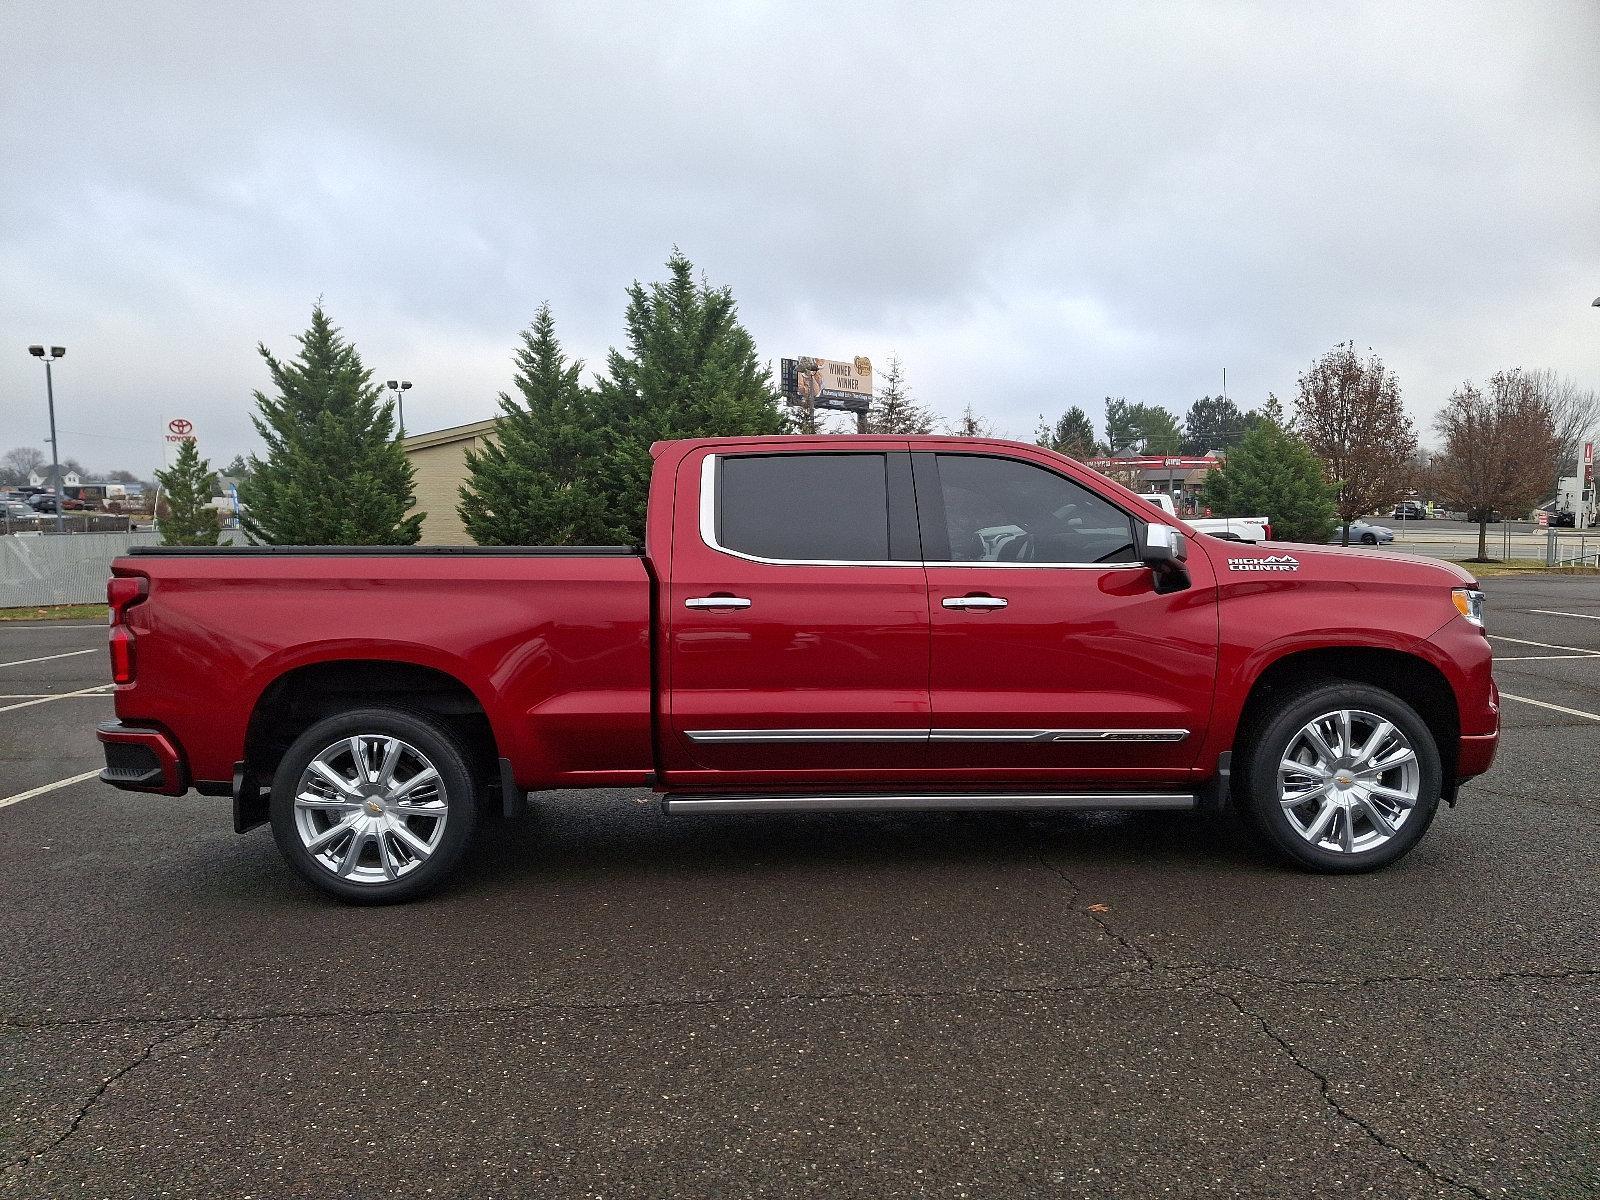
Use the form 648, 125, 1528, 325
662, 438, 928, 786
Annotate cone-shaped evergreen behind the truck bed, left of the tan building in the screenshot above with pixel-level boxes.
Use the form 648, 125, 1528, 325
240, 304, 422, 546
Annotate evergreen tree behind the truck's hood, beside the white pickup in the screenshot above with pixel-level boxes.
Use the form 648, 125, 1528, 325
1202, 418, 1338, 542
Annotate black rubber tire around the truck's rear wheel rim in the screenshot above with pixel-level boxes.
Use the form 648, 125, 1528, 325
270, 707, 480, 904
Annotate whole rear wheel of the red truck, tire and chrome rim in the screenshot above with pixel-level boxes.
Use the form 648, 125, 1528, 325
270, 709, 478, 904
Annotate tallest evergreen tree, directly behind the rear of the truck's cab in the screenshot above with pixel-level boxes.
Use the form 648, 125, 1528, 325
595, 250, 787, 541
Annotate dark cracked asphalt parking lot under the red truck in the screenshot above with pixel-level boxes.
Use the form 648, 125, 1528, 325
0, 576, 1600, 1197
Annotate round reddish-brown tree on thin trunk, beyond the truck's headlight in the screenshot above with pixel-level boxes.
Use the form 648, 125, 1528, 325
1434, 370, 1562, 562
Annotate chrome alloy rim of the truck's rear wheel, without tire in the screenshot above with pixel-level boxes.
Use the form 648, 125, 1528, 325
294, 733, 450, 883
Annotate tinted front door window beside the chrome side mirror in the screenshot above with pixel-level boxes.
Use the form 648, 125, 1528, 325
930, 454, 1138, 563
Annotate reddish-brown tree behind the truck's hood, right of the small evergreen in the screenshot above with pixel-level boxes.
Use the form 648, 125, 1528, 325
1294, 342, 1416, 546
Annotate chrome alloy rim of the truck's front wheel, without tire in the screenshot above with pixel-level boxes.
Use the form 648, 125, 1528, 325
1278, 709, 1422, 854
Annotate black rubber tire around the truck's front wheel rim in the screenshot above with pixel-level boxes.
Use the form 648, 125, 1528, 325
1234, 680, 1443, 874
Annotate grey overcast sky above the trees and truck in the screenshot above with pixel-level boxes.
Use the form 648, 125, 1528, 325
0, 0, 1600, 472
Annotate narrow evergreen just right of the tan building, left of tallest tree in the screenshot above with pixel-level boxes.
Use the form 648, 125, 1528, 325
458, 304, 614, 546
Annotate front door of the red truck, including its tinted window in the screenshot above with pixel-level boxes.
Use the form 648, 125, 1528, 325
914, 451, 1218, 782
